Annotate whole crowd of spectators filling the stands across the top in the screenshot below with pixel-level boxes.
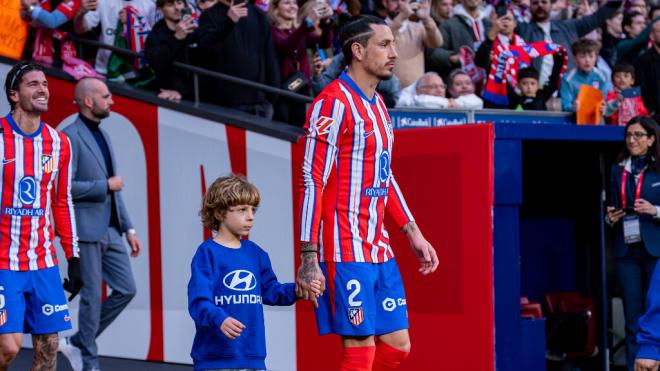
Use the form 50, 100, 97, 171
14, 0, 660, 126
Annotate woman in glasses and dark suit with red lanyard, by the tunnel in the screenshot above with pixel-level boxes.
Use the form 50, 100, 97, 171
605, 116, 660, 370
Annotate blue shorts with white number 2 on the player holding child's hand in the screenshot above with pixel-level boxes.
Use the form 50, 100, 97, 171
316, 259, 408, 336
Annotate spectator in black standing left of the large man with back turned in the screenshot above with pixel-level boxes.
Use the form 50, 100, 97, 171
145, 0, 197, 101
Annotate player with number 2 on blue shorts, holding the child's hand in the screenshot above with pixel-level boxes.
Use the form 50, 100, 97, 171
296, 16, 438, 370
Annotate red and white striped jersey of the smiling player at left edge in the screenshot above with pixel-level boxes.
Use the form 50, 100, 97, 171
0, 114, 78, 271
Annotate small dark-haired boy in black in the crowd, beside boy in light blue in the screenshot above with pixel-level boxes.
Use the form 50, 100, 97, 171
507, 65, 561, 111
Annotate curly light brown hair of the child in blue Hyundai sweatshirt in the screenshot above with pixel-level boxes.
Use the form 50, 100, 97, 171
199, 174, 261, 231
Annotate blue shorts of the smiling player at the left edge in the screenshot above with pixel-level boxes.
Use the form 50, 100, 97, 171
0, 266, 71, 335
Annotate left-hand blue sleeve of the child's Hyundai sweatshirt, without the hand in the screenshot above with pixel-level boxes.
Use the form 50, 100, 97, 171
188, 253, 229, 328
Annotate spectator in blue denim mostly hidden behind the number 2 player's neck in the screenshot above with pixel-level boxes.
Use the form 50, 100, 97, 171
312, 53, 401, 108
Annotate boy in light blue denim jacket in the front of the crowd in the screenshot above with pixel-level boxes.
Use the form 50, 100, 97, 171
559, 39, 607, 112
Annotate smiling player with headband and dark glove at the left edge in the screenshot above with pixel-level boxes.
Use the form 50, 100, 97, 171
0, 62, 82, 371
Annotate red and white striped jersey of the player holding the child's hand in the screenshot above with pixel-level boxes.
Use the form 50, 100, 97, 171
300, 72, 413, 263
